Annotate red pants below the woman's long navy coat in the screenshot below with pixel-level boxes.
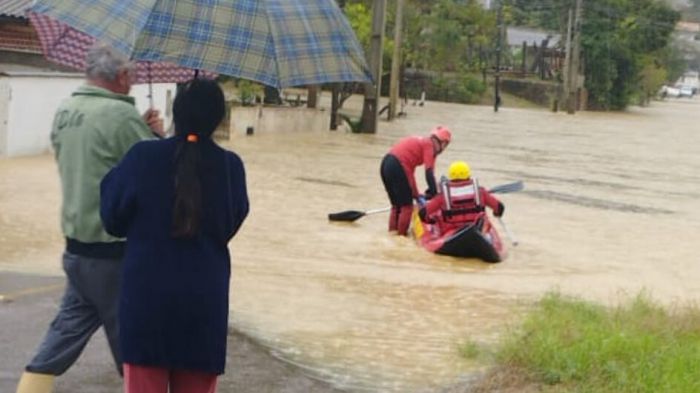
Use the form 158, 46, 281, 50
124, 363, 217, 393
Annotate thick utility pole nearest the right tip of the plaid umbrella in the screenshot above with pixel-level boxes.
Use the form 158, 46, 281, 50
362, 0, 386, 134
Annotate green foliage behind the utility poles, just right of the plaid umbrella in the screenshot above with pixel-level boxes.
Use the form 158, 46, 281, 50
344, 0, 496, 102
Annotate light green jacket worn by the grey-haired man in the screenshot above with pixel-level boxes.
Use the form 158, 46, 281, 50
51, 85, 154, 243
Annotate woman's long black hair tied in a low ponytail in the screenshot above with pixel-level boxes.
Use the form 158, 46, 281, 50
172, 79, 226, 238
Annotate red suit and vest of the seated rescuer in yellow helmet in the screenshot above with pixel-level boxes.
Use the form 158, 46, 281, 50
424, 179, 503, 233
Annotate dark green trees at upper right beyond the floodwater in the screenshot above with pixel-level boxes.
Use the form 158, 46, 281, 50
508, 0, 680, 110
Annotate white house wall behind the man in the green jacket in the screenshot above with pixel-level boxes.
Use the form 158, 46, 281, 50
0, 73, 175, 157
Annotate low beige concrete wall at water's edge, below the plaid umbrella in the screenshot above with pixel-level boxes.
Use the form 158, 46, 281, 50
229, 106, 330, 138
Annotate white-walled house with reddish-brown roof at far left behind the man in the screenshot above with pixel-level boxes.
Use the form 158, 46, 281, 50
0, 0, 176, 158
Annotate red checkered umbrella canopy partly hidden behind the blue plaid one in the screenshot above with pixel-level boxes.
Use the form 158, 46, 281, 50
29, 12, 209, 83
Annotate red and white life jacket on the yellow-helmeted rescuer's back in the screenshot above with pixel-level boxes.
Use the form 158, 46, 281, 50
441, 179, 485, 223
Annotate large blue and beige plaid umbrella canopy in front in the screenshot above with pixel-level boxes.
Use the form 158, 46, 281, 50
31, 0, 371, 87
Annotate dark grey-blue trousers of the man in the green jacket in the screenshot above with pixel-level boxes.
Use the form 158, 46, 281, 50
26, 252, 122, 375
